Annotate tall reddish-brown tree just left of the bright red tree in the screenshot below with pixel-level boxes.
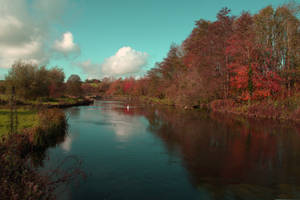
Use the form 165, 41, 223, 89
183, 8, 234, 101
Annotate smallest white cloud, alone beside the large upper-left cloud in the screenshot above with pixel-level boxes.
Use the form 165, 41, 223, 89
54, 32, 80, 56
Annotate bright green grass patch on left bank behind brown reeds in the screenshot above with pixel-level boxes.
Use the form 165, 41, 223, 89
0, 108, 38, 137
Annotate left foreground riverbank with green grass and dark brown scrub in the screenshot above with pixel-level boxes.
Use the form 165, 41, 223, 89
0, 109, 68, 199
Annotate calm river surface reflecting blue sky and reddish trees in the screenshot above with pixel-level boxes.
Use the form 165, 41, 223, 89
44, 101, 300, 200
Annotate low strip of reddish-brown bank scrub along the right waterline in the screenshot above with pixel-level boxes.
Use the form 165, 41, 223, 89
104, 96, 300, 124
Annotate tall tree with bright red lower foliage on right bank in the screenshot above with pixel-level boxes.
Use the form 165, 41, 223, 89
226, 13, 280, 100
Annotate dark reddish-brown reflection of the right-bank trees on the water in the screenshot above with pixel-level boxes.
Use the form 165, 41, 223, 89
114, 104, 300, 199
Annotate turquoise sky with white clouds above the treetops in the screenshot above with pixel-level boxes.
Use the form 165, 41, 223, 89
0, 0, 287, 79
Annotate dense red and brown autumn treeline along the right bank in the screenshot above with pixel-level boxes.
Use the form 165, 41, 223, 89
100, 4, 300, 108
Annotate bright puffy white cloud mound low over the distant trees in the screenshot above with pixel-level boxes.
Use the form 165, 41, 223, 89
101, 47, 148, 76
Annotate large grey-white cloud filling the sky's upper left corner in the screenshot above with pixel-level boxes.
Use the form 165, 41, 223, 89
0, 0, 79, 68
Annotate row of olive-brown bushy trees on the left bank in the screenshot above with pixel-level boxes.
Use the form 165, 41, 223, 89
0, 62, 82, 100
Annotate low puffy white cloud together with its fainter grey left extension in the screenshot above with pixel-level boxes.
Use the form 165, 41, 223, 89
75, 47, 148, 78
